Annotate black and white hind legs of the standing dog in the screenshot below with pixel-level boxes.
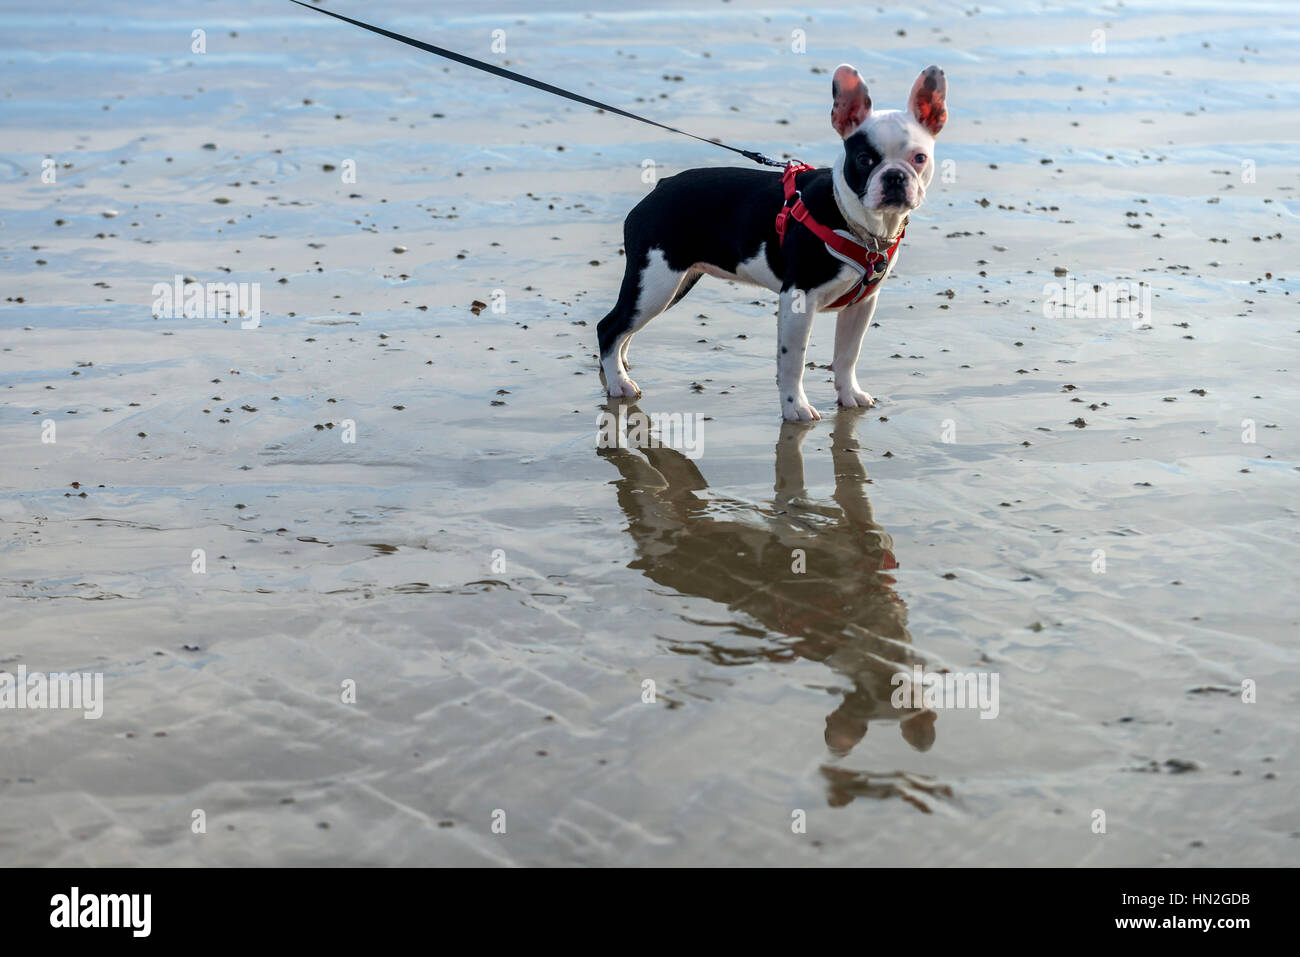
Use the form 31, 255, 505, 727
595, 250, 699, 398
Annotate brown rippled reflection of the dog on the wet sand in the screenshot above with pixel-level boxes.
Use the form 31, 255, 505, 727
598, 403, 936, 804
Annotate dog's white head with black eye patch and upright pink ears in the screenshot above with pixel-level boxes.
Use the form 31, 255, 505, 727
831, 64, 948, 216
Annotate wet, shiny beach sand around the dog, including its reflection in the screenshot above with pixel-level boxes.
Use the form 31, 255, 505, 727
0, 0, 1300, 866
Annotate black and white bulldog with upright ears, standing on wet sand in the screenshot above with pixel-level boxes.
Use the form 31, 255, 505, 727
598, 65, 948, 421
